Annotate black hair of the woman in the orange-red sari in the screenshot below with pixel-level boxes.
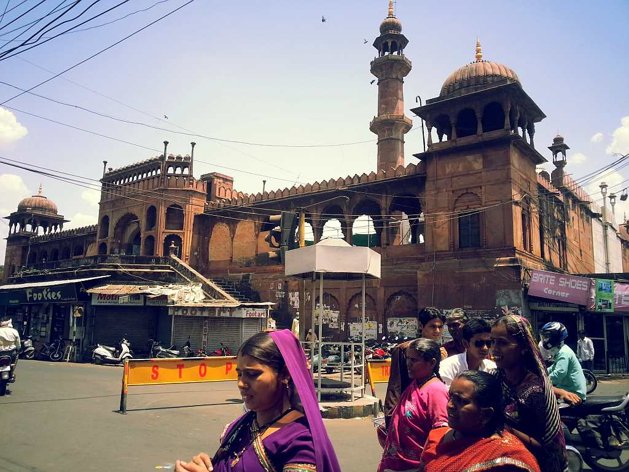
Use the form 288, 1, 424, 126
455, 370, 505, 436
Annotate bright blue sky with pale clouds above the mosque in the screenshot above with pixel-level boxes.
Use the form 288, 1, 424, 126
0, 0, 629, 254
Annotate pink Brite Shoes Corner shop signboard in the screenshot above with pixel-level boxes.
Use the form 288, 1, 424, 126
528, 270, 594, 305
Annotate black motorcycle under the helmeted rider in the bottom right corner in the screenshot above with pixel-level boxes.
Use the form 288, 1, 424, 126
559, 394, 629, 472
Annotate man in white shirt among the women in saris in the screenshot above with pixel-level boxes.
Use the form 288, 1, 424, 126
439, 318, 496, 387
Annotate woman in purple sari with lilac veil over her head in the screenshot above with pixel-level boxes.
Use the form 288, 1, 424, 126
175, 330, 341, 472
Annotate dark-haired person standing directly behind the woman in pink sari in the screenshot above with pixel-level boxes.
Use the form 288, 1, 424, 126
384, 306, 448, 426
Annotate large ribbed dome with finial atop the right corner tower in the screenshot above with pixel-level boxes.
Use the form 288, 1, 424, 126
439, 41, 520, 97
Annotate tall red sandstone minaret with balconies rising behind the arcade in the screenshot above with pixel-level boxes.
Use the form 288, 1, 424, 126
369, 0, 413, 170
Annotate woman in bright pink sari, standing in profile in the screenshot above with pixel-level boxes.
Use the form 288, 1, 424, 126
378, 338, 448, 472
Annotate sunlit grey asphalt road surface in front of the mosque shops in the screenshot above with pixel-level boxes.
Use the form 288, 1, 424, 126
0, 361, 629, 472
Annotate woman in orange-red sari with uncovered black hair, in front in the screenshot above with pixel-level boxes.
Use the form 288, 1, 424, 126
419, 370, 540, 472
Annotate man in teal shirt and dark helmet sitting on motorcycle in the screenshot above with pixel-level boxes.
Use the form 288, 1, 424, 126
540, 321, 587, 404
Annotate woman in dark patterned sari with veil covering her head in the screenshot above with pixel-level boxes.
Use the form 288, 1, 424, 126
491, 315, 567, 472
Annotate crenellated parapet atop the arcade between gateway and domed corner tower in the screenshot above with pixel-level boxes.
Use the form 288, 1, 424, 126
206, 162, 424, 210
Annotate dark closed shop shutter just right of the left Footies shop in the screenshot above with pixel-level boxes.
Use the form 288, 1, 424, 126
94, 306, 157, 352
